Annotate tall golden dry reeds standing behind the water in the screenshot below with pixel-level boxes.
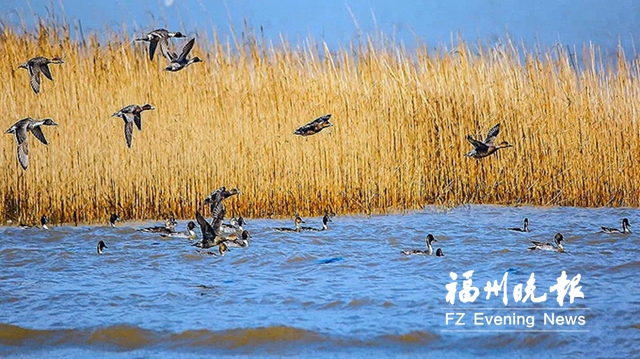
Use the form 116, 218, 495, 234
0, 26, 640, 223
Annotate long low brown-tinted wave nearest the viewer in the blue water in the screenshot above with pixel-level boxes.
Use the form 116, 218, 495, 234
0, 324, 440, 351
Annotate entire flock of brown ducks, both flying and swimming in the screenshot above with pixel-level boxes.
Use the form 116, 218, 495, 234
6, 29, 631, 257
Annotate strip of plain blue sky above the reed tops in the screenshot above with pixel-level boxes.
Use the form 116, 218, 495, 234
0, 0, 640, 52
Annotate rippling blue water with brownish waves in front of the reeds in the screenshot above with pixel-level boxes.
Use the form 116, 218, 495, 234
0, 206, 640, 358
